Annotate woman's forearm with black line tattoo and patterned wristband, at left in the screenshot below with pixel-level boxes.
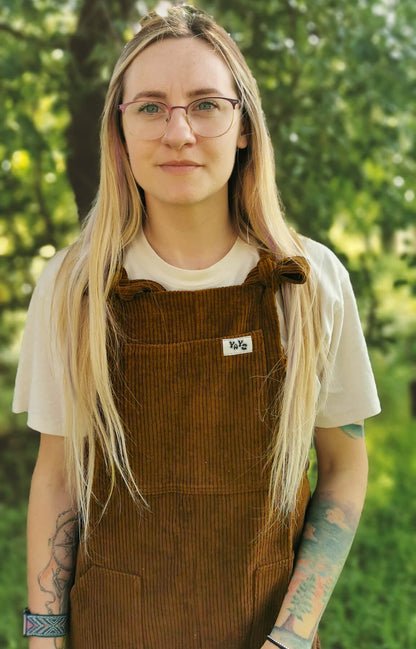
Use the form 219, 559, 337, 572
27, 440, 78, 649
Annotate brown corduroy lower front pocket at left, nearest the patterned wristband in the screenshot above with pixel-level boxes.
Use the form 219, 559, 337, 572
70, 566, 143, 649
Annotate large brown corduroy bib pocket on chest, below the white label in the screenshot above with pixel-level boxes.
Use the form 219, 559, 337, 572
121, 330, 270, 494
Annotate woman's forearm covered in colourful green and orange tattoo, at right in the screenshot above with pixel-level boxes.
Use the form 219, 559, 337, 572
265, 422, 367, 649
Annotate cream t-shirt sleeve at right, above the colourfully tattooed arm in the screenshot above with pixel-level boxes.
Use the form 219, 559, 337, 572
315, 243, 380, 428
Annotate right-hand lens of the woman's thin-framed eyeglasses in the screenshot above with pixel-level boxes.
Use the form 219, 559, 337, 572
188, 97, 234, 137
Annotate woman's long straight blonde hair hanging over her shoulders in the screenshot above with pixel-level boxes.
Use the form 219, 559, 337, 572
54, 6, 321, 538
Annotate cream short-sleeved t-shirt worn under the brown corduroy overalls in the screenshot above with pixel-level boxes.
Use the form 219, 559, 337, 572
13, 232, 380, 435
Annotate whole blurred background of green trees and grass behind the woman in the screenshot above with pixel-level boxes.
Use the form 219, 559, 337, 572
0, 0, 416, 649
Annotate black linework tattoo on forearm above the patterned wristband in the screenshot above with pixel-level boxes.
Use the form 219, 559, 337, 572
38, 509, 78, 615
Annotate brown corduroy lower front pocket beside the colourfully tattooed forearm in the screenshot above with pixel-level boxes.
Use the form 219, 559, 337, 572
250, 559, 293, 649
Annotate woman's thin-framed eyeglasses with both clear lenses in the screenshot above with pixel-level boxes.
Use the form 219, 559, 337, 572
119, 97, 240, 140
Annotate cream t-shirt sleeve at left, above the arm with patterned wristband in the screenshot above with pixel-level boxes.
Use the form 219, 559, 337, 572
13, 251, 64, 436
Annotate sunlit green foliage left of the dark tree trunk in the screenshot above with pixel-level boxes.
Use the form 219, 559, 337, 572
0, 0, 77, 432
